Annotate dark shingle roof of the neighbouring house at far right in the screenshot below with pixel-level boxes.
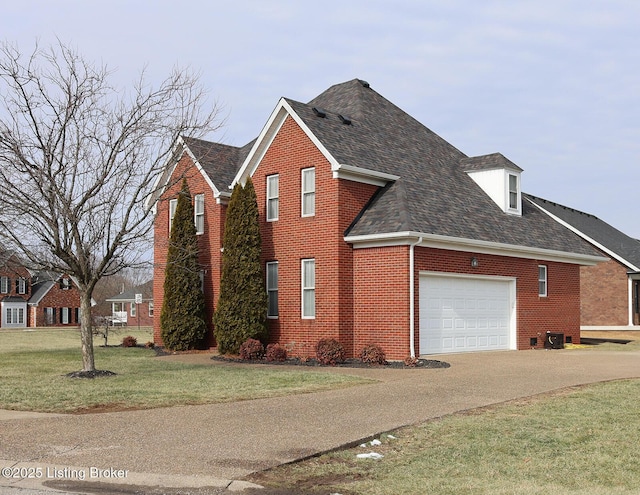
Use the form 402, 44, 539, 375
527, 195, 640, 268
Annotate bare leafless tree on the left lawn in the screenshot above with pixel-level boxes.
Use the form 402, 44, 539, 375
0, 42, 220, 372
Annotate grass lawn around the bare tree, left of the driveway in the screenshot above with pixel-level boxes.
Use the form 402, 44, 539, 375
0, 327, 367, 413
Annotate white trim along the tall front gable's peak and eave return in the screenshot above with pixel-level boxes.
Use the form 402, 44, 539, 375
229, 98, 399, 189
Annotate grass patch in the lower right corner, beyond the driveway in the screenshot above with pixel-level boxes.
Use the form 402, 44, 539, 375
253, 380, 640, 495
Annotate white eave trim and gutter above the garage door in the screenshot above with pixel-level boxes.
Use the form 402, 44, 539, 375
344, 231, 607, 265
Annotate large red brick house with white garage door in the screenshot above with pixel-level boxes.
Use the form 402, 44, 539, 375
149, 79, 605, 359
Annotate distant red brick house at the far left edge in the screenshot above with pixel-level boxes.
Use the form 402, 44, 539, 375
0, 252, 80, 328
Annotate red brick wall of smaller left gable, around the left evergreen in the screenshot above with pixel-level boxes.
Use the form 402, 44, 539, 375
153, 153, 226, 345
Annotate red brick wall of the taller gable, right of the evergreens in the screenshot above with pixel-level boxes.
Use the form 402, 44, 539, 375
252, 117, 377, 356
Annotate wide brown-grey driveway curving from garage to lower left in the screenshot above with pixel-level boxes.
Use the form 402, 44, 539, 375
0, 350, 640, 489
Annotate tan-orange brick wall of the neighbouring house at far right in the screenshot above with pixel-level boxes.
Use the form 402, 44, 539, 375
580, 260, 629, 326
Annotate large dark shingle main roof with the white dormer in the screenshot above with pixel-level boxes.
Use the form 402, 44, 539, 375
296, 79, 597, 255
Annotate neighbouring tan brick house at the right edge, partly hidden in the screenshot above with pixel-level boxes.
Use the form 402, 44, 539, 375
528, 196, 640, 331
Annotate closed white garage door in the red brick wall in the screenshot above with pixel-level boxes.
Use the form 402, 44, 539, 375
420, 275, 516, 354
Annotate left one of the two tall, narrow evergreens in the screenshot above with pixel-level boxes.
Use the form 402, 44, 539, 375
160, 180, 207, 351
